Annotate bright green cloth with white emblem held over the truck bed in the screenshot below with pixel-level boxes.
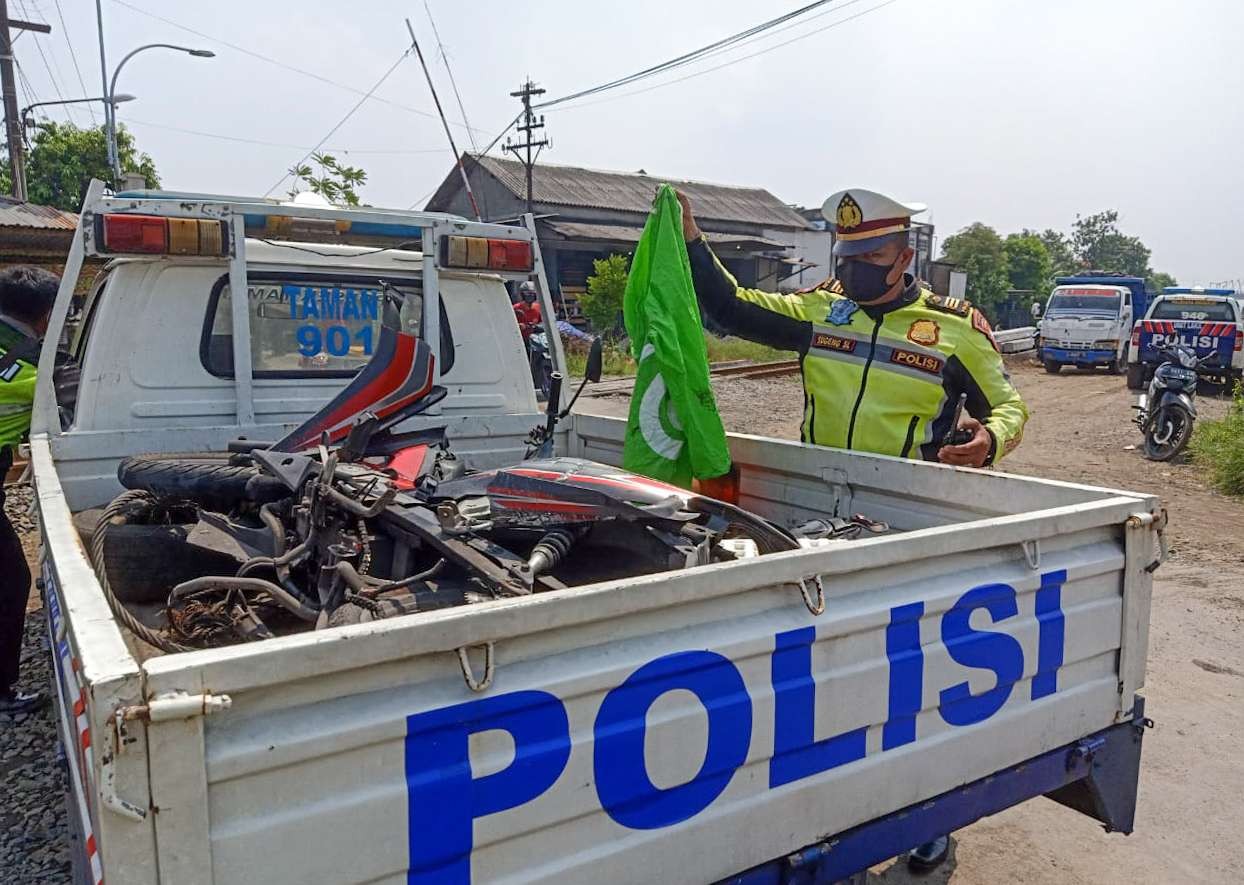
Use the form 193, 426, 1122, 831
622, 184, 730, 488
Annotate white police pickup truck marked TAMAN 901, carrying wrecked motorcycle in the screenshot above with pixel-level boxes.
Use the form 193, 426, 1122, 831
31, 184, 1163, 885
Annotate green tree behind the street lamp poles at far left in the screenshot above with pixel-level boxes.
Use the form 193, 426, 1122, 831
0, 122, 159, 212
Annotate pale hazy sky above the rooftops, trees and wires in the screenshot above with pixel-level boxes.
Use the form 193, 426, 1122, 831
9, 0, 1244, 285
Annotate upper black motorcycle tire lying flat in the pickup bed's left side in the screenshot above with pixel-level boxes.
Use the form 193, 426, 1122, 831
117, 454, 290, 505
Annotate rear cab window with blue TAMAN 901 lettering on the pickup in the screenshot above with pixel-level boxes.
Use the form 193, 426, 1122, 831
200, 274, 454, 377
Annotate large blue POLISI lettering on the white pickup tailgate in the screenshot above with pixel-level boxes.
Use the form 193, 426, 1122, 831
406, 570, 1067, 885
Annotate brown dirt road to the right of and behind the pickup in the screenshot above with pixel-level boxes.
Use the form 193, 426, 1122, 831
586, 362, 1244, 885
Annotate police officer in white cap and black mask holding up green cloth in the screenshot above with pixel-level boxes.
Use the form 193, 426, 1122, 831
678, 188, 1028, 871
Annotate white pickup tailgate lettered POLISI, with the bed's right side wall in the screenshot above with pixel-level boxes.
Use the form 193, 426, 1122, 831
118, 417, 1157, 885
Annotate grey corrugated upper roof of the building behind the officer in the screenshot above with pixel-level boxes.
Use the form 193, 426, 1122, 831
442, 154, 809, 230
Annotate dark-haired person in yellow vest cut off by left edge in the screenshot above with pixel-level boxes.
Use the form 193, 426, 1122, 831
0, 265, 60, 713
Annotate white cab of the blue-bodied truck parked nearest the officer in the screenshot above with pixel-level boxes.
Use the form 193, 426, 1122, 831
1037, 284, 1132, 373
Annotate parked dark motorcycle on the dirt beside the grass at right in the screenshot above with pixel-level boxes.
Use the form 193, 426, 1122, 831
1133, 344, 1218, 461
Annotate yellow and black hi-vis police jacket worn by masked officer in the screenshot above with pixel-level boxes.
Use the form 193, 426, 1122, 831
688, 239, 1028, 463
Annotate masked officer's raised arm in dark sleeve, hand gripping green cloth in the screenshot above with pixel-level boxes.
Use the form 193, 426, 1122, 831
677, 190, 812, 354
